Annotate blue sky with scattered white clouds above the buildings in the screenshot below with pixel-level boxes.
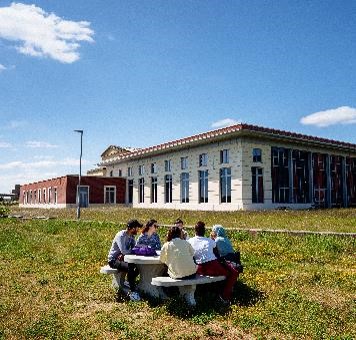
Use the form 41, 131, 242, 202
0, 0, 356, 193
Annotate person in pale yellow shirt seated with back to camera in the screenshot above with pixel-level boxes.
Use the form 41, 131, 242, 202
160, 227, 197, 279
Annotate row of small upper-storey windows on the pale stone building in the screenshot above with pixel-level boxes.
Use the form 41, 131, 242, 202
125, 148, 262, 177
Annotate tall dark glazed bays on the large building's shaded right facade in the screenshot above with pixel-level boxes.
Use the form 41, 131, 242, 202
271, 147, 356, 207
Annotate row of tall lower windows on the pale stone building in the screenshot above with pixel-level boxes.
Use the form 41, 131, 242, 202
128, 167, 264, 204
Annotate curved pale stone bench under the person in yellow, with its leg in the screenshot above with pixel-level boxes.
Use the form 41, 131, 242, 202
151, 275, 226, 306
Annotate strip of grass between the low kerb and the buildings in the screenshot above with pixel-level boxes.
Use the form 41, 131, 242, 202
7, 206, 356, 232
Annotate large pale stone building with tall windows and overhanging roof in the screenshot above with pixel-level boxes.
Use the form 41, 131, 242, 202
98, 124, 356, 211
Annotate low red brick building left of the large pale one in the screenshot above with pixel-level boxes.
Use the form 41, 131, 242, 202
19, 175, 126, 208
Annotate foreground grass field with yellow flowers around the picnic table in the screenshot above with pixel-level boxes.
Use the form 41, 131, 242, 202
0, 210, 356, 339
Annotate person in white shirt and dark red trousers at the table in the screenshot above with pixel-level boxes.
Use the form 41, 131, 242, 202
188, 221, 239, 303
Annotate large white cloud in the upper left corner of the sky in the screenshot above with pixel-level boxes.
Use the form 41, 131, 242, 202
0, 3, 94, 63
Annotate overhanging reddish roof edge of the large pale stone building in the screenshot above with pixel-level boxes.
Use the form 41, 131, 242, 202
98, 123, 356, 166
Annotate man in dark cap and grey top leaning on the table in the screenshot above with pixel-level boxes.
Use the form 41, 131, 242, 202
108, 220, 142, 301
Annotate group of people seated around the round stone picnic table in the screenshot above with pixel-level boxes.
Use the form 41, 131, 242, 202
108, 219, 242, 303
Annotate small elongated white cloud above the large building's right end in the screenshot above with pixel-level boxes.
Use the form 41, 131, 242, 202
300, 106, 356, 127
